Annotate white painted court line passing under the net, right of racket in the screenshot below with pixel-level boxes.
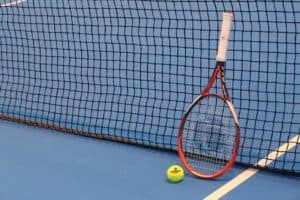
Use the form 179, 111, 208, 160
204, 135, 300, 200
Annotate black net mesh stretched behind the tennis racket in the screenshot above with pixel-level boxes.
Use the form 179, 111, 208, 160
0, 0, 300, 175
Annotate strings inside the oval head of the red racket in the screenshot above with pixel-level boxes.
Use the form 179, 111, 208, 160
182, 96, 236, 175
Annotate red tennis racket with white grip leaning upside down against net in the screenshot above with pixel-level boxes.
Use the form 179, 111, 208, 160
178, 12, 240, 179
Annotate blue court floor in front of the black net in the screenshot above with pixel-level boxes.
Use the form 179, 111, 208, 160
0, 120, 300, 200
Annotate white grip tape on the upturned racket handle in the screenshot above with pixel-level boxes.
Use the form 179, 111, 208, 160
217, 12, 233, 62
